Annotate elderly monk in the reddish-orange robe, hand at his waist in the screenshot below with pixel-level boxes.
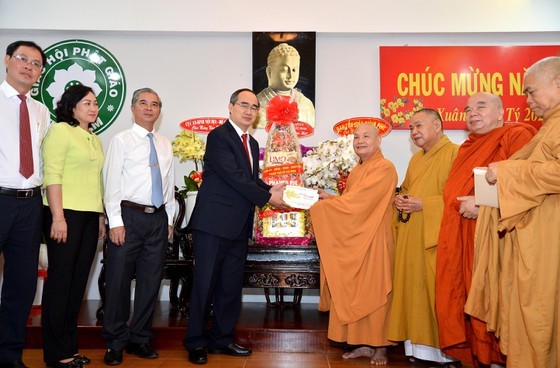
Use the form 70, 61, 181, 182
436, 92, 536, 367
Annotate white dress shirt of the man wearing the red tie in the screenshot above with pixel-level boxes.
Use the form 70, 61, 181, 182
0, 81, 51, 189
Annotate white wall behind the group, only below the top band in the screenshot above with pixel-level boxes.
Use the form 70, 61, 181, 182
0, 30, 560, 179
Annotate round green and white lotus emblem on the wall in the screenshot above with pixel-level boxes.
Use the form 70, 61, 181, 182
31, 40, 126, 134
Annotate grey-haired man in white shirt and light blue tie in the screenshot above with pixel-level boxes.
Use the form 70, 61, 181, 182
103, 88, 175, 365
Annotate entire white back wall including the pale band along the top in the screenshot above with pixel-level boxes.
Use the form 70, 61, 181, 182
0, 0, 560, 301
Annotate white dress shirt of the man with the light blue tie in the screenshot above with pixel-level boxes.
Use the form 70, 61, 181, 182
103, 124, 175, 229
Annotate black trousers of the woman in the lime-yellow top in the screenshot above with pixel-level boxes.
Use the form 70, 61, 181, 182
41, 206, 99, 362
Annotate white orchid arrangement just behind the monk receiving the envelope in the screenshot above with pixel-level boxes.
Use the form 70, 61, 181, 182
303, 135, 358, 192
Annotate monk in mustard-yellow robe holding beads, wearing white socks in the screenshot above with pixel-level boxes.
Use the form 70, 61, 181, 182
389, 109, 459, 365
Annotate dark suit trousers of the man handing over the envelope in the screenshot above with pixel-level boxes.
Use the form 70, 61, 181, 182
183, 230, 248, 350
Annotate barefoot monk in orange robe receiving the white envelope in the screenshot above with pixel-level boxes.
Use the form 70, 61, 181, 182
310, 124, 397, 365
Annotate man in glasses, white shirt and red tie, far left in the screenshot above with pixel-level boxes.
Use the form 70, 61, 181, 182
0, 41, 50, 368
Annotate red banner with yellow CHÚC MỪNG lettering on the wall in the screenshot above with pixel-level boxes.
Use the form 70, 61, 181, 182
379, 45, 560, 129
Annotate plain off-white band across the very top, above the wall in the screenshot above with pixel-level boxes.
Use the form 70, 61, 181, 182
0, 0, 560, 33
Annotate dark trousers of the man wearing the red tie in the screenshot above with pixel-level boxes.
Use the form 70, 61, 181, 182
0, 195, 43, 364
